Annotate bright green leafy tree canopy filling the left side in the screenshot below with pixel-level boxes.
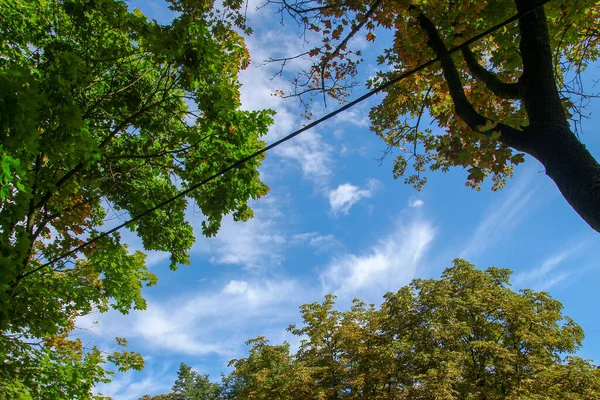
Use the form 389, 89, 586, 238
0, 0, 272, 399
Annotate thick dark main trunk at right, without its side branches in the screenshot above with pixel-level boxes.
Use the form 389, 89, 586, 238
516, 0, 600, 232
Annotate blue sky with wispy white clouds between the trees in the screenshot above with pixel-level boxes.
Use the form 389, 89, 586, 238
84, 1, 600, 400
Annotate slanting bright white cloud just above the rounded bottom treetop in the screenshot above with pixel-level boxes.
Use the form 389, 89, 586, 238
320, 219, 436, 298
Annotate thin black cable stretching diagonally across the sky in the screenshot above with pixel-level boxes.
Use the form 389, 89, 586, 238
20, 0, 550, 279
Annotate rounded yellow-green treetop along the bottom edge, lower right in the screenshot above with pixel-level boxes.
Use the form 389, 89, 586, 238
231, 259, 600, 400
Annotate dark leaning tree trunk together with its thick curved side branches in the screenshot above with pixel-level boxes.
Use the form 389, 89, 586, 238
418, 0, 600, 232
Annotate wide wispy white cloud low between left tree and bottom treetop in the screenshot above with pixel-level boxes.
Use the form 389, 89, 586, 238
85, 279, 310, 361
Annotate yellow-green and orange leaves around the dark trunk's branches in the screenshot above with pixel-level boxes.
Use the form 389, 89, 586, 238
269, 0, 600, 190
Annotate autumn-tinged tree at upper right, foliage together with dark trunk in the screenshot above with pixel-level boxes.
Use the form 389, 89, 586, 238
269, 0, 600, 231
